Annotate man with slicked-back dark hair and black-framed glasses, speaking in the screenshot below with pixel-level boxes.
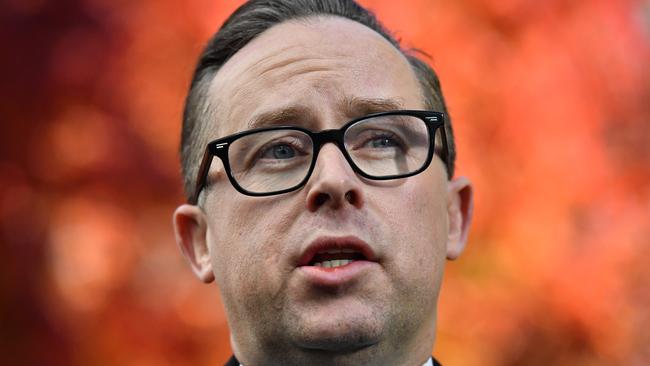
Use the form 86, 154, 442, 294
173, 0, 472, 366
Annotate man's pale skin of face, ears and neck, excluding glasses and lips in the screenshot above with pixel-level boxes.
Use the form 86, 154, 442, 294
173, 17, 472, 366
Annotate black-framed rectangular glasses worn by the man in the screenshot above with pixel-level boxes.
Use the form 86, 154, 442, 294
190, 110, 449, 204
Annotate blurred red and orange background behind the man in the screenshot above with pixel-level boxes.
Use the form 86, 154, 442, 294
0, 0, 650, 366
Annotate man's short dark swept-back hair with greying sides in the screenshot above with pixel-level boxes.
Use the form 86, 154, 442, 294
180, 0, 456, 198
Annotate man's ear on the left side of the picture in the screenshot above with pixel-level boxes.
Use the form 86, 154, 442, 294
173, 204, 214, 283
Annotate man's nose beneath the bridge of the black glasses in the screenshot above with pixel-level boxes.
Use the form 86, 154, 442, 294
305, 143, 364, 211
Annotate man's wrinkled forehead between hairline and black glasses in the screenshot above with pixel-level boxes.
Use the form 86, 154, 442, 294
208, 16, 422, 137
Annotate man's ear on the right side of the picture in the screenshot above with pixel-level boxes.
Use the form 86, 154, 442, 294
447, 177, 474, 259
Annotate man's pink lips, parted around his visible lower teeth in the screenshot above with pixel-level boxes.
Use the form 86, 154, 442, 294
297, 236, 379, 287
